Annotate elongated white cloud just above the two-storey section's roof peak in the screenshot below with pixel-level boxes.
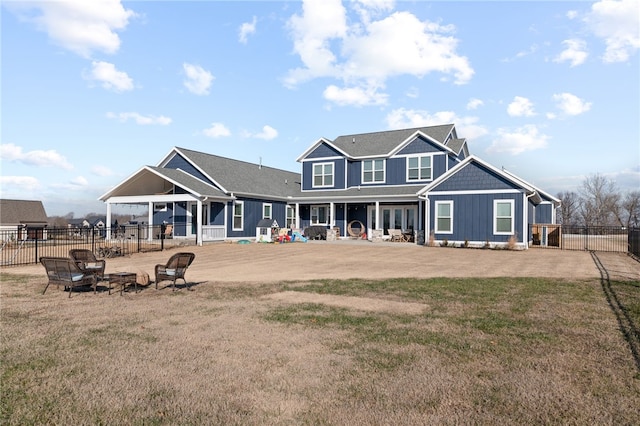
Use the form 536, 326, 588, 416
386, 108, 488, 140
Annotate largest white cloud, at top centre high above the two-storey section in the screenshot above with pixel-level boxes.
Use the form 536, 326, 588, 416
284, 0, 474, 105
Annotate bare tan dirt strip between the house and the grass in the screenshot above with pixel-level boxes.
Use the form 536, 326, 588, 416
1, 241, 640, 283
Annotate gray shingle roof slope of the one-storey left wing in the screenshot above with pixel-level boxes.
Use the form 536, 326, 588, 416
176, 148, 301, 198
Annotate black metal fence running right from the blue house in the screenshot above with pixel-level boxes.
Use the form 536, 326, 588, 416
530, 224, 640, 256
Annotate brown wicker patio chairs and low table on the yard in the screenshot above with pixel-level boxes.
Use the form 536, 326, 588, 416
40, 249, 195, 297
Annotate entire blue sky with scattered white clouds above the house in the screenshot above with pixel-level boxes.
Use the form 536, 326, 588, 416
0, 0, 640, 217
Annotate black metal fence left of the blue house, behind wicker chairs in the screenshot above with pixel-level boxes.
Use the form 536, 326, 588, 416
0, 225, 189, 266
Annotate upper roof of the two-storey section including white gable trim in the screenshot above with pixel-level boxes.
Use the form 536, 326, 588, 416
297, 124, 462, 161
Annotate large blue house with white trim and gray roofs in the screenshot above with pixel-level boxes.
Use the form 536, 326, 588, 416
100, 124, 560, 248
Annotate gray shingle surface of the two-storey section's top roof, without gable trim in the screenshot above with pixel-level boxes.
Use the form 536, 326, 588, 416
332, 124, 454, 158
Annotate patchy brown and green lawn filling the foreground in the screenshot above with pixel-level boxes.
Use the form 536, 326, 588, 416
0, 274, 640, 425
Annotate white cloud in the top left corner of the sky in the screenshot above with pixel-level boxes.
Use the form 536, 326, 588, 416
3, 0, 136, 58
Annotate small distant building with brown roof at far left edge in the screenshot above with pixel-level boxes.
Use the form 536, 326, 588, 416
0, 199, 47, 240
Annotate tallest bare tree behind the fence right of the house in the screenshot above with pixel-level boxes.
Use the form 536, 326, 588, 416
580, 173, 620, 226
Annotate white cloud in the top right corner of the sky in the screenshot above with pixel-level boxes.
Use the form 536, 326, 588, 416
585, 0, 640, 63
